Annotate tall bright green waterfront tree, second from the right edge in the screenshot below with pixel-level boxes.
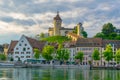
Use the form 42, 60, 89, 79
103, 44, 113, 62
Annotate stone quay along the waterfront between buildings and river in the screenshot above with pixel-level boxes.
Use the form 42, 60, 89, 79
0, 63, 120, 70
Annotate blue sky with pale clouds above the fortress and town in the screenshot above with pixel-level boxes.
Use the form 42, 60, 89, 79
0, 0, 120, 44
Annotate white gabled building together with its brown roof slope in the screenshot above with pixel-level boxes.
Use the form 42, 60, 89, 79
13, 35, 45, 62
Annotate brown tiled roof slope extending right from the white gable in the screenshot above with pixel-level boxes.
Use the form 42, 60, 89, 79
25, 36, 46, 51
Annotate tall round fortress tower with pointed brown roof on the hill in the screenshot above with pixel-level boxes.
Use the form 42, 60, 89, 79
53, 12, 62, 36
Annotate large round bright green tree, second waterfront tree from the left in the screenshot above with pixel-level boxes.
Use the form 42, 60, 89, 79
42, 45, 54, 61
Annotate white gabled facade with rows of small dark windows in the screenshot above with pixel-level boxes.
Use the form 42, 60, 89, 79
13, 35, 33, 62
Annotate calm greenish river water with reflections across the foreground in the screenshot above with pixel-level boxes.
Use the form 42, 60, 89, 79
0, 68, 120, 80
